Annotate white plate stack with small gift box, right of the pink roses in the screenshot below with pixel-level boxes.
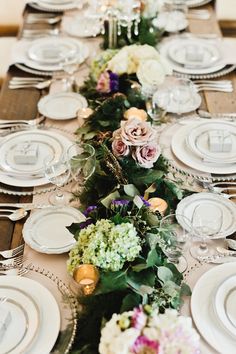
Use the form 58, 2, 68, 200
159, 117, 236, 180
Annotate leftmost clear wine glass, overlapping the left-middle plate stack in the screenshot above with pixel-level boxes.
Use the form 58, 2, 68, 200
44, 154, 70, 206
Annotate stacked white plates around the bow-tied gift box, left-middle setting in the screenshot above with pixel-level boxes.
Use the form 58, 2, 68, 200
0, 129, 72, 187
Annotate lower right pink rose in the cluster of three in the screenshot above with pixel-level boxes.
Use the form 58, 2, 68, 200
132, 143, 161, 168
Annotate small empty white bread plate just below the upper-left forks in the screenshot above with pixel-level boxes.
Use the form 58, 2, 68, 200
38, 92, 88, 120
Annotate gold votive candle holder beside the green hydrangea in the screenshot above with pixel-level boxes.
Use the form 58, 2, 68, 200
73, 264, 99, 295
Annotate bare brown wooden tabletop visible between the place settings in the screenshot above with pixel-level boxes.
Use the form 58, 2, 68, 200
0, 5, 236, 250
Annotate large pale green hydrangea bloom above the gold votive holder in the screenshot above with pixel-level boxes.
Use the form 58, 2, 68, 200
67, 219, 141, 274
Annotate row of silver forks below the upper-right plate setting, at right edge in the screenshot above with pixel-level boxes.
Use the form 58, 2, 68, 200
194, 80, 234, 92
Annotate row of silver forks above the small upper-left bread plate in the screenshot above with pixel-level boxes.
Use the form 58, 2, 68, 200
8, 77, 53, 90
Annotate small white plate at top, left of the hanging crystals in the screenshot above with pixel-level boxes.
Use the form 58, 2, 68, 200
62, 16, 101, 38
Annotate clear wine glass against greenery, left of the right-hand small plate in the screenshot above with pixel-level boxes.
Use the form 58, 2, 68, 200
160, 214, 191, 273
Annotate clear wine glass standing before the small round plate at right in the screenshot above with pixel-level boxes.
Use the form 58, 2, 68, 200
190, 203, 223, 259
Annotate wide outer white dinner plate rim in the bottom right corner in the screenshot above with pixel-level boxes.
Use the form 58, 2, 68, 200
191, 263, 235, 354
